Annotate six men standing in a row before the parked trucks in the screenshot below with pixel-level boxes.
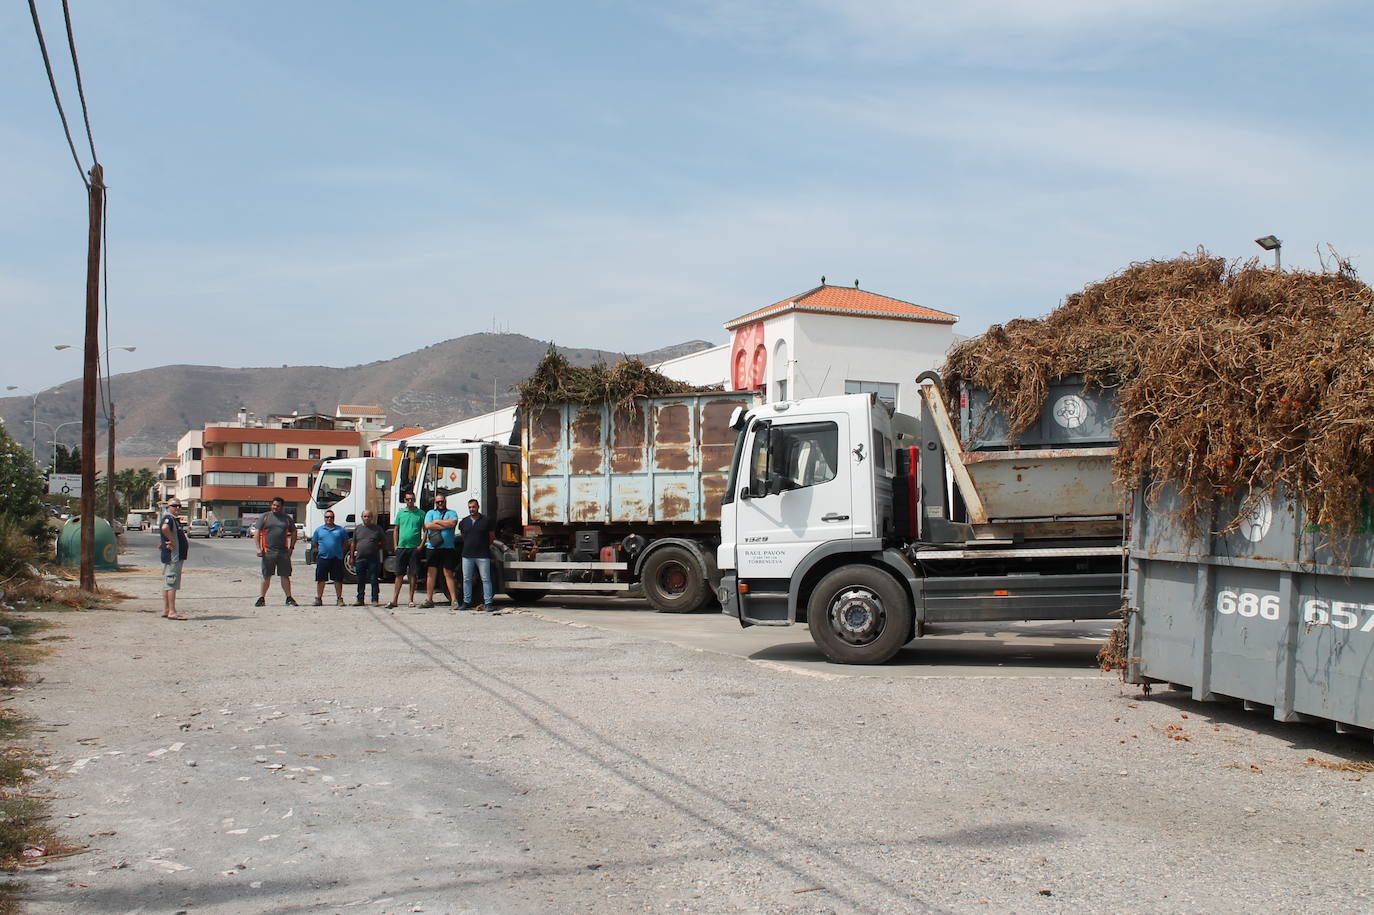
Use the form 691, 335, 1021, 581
254, 492, 495, 610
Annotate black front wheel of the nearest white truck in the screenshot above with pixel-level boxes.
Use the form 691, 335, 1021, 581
807, 566, 911, 664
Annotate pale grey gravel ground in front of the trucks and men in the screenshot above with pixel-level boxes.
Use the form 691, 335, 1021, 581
12, 560, 1374, 912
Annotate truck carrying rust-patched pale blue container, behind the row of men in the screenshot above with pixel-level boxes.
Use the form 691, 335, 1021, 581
390, 392, 753, 613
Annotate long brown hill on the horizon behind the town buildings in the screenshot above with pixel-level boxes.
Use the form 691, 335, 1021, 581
8, 334, 712, 458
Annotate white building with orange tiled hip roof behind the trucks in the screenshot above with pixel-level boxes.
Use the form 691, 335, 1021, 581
412, 278, 959, 442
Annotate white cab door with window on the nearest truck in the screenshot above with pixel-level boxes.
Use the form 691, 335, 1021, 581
735, 412, 853, 579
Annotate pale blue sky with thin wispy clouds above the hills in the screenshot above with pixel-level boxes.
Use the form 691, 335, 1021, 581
0, 0, 1374, 387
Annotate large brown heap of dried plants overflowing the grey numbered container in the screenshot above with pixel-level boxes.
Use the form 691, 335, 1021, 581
943, 249, 1374, 536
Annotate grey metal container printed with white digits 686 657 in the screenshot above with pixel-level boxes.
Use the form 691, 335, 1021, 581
1127, 486, 1374, 732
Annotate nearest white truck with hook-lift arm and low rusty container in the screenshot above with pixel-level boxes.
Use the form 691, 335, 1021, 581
716, 372, 1124, 664
